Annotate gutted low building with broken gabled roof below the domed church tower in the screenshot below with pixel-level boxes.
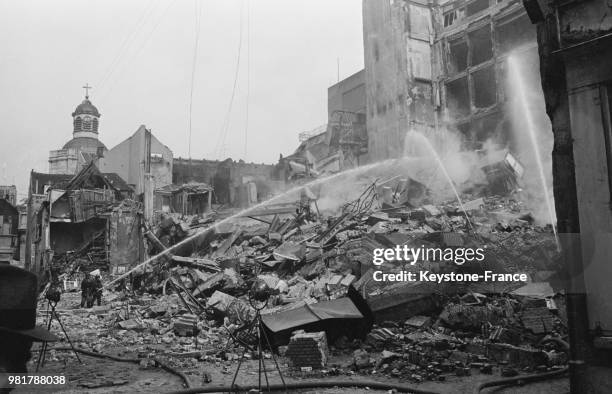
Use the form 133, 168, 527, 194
25, 162, 142, 273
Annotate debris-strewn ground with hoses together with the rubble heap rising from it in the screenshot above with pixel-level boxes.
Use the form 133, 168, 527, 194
32, 170, 567, 392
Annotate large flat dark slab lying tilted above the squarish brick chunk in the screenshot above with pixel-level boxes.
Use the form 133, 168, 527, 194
261, 298, 363, 332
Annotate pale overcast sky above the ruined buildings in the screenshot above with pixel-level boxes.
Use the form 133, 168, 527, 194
0, 0, 363, 197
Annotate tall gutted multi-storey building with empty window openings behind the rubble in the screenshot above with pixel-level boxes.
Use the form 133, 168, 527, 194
363, 0, 539, 161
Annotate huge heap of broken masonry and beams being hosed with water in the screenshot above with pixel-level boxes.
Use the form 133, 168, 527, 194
51, 177, 567, 381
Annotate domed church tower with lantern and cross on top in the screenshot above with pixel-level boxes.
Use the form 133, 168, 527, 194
49, 85, 107, 174
